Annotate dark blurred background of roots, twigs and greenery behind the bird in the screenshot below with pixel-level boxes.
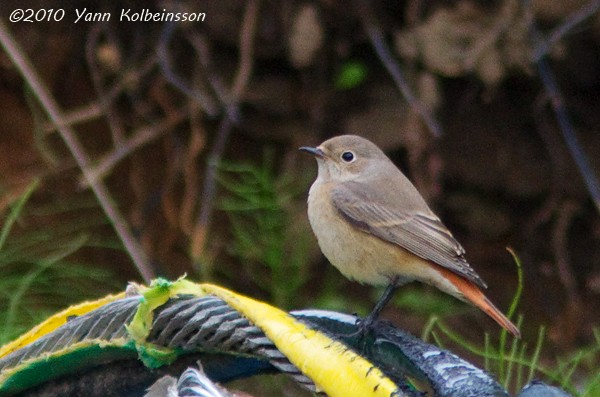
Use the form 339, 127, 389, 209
0, 0, 600, 395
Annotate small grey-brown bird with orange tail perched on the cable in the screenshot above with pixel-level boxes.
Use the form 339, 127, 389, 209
300, 135, 520, 337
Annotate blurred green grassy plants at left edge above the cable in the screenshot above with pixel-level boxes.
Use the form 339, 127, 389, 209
0, 182, 117, 344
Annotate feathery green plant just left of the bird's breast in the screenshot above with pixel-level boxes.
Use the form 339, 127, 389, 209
219, 151, 312, 308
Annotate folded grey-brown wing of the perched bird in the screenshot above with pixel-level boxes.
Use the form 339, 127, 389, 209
332, 182, 487, 288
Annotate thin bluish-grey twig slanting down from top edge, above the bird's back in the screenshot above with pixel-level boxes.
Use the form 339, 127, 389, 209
358, 0, 442, 138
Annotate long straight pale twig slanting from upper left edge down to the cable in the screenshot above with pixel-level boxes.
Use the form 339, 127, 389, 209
0, 21, 154, 282
